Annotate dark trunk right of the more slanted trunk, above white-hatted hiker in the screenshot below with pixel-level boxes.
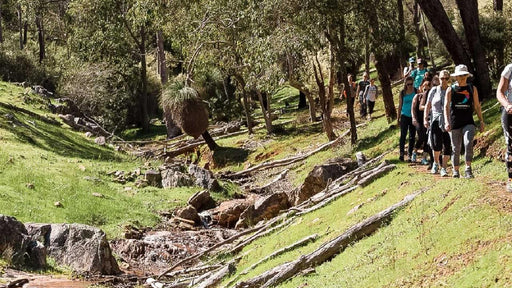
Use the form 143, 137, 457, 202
456, 0, 492, 98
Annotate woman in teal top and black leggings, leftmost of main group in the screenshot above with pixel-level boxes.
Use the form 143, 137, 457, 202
397, 76, 416, 161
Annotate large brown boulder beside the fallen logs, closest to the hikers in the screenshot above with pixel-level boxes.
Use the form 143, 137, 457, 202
288, 159, 357, 206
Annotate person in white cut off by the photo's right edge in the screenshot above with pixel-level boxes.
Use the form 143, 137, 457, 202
496, 64, 512, 192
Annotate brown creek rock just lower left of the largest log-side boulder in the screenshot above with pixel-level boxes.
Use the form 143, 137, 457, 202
235, 192, 290, 229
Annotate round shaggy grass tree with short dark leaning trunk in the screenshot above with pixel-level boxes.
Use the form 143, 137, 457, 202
161, 79, 218, 151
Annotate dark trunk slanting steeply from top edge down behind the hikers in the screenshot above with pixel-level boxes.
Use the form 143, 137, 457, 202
417, 0, 471, 67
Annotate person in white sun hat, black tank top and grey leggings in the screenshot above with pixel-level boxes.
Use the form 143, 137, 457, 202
444, 64, 485, 178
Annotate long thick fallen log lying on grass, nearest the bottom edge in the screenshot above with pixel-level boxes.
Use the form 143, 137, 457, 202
236, 188, 426, 288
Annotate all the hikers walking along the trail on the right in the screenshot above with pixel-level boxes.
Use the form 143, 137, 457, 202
342, 57, 512, 192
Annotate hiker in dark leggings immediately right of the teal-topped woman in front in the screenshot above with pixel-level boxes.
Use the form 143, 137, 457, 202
411, 81, 433, 165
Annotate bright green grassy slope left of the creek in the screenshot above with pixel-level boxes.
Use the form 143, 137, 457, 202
0, 83, 203, 237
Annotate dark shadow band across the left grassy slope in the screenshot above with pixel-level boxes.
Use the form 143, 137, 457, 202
0, 109, 120, 161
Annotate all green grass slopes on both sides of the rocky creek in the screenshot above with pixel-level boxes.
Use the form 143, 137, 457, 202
0, 77, 512, 287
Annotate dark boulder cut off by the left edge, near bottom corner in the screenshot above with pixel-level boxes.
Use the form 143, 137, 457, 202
0, 214, 29, 265
